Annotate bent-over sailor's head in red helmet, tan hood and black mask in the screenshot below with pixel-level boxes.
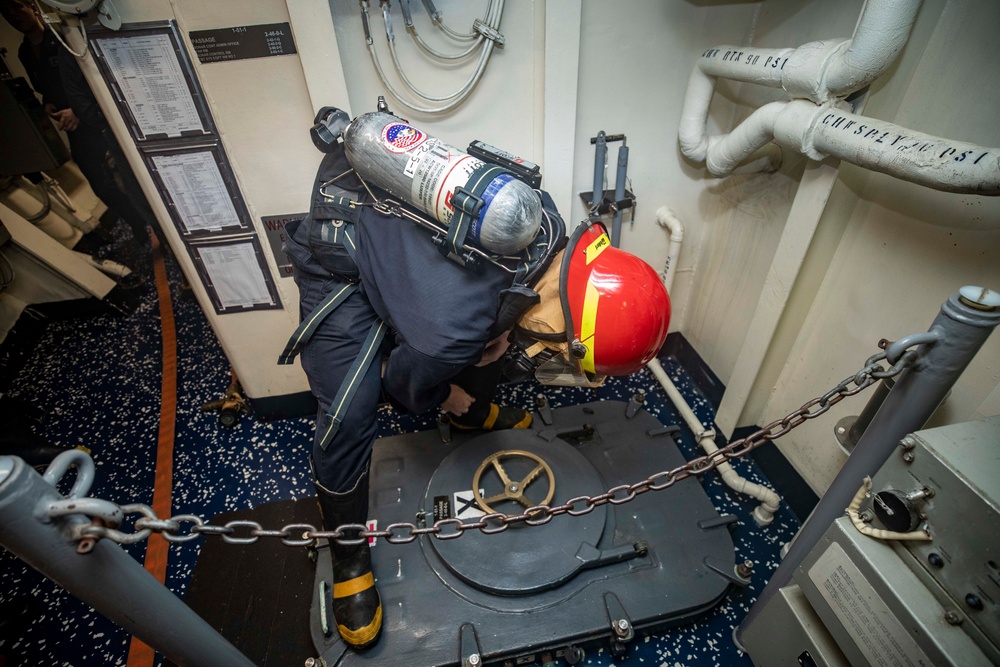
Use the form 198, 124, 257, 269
514, 223, 670, 387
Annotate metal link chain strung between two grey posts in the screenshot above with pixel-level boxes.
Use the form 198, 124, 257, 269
77, 349, 918, 547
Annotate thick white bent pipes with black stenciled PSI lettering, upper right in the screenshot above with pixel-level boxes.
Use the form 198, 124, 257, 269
678, 0, 1000, 195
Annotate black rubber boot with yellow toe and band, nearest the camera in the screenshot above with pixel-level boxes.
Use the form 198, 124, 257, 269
313, 470, 382, 651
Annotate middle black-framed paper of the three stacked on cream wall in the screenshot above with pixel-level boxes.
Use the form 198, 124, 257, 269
143, 145, 250, 238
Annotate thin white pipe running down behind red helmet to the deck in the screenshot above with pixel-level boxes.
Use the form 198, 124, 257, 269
646, 206, 781, 526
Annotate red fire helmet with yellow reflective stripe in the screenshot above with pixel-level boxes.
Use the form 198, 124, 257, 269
566, 223, 670, 375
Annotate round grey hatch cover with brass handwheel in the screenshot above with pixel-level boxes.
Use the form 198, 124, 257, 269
424, 429, 607, 595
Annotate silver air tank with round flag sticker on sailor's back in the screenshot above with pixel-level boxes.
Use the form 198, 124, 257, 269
344, 112, 542, 255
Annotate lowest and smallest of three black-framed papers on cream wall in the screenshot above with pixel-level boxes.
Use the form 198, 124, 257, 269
188, 236, 282, 314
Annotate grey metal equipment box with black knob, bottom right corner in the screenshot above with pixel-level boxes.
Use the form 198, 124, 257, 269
743, 416, 1000, 667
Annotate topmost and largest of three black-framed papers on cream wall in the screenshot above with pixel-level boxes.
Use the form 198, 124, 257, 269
90, 21, 214, 142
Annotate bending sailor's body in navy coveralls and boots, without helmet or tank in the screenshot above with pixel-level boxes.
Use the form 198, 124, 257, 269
283, 147, 555, 648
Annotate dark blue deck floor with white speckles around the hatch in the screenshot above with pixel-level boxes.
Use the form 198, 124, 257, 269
0, 226, 799, 667
